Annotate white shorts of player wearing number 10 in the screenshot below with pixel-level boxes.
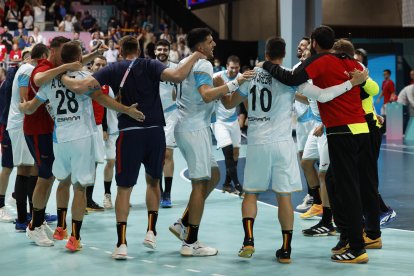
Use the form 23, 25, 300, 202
243, 140, 302, 194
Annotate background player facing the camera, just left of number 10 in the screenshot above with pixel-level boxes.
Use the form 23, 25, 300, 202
214, 56, 243, 195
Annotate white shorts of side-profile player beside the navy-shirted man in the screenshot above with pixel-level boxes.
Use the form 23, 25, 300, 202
175, 127, 218, 180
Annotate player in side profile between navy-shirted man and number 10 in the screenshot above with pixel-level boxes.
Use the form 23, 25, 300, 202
170, 28, 254, 256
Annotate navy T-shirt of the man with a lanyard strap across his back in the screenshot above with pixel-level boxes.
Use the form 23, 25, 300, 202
93, 58, 167, 130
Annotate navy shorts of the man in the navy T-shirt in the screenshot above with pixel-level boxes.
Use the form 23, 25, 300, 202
115, 127, 165, 187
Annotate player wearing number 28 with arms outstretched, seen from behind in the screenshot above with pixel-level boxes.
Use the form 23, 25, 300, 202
19, 42, 143, 251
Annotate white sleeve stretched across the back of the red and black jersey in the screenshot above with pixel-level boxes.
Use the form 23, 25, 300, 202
298, 81, 352, 103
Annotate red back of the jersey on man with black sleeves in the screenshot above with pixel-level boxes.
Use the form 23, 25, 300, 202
305, 55, 366, 128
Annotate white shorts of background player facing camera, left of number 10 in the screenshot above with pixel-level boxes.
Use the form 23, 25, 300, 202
214, 121, 241, 148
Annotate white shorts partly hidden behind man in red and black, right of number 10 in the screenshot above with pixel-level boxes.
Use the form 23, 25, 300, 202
302, 128, 330, 172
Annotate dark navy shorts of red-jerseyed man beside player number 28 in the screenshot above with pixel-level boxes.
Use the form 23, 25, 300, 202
24, 134, 55, 179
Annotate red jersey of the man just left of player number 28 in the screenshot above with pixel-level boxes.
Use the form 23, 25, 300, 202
23, 59, 55, 135
